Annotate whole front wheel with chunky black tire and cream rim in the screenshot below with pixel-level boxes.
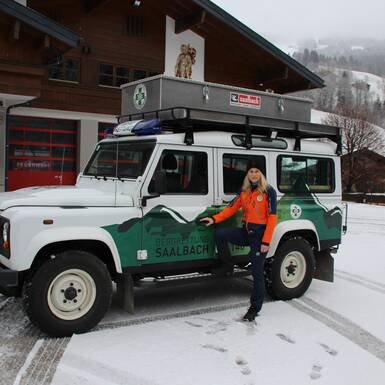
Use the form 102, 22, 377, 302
23, 250, 112, 337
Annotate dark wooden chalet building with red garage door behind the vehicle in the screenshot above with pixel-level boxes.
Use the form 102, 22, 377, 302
0, 0, 323, 190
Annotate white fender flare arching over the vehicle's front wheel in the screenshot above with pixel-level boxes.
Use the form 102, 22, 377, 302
17, 227, 122, 273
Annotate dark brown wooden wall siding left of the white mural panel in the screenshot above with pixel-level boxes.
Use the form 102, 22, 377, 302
29, 0, 166, 115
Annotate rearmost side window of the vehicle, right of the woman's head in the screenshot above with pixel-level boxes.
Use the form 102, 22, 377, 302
278, 156, 334, 193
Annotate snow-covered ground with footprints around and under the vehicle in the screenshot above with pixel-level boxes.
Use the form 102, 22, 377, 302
45, 204, 385, 385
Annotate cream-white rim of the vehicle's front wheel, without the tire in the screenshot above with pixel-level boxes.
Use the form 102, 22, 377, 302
47, 269, 96, 321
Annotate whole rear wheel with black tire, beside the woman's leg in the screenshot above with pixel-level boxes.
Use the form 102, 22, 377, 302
266, 238, 315, 300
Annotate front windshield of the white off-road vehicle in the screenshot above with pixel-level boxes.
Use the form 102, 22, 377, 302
83, 141, 155, 179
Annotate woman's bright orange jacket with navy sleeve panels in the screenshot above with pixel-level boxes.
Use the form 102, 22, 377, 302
212, 186, 278, 245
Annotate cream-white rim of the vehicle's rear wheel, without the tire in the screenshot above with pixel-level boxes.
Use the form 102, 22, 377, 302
281, 251, 306, 289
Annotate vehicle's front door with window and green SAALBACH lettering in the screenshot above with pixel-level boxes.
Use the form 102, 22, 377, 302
141, 145, 215, 264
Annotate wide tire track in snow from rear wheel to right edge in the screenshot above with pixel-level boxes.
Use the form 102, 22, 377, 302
287, 297, 385, 362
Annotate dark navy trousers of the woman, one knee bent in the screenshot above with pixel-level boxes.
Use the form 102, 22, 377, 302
214, 223, 266, 312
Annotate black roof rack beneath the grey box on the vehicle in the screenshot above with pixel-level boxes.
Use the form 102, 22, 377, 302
118, 107, 342, 155
